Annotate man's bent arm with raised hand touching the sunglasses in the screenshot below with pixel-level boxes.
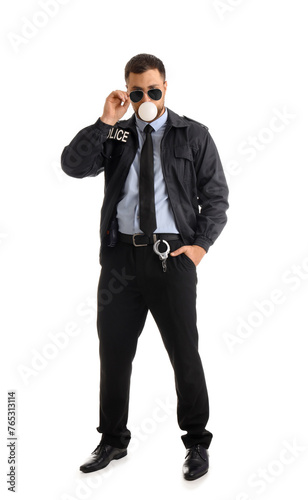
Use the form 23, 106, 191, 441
61, 90, 130, 178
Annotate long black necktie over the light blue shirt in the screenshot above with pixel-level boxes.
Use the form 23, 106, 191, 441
139, 125, 157, 236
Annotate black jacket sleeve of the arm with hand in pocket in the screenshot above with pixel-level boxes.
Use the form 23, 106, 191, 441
194, 127, 229, 252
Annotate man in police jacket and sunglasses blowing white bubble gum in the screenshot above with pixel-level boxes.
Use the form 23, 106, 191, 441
61, 54, 228, 480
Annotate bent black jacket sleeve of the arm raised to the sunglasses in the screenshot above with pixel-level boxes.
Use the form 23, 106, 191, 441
61, 118, 111, 178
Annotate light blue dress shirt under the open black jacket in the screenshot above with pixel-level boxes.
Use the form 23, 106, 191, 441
117, 109, 179, 234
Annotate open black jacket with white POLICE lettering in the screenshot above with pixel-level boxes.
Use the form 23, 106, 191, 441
61, 109, 229, 262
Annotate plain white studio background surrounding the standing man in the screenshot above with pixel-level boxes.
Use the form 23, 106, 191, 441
0, 0, 308, 500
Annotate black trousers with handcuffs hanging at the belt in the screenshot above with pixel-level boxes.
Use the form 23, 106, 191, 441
97, 239, 213, 448
